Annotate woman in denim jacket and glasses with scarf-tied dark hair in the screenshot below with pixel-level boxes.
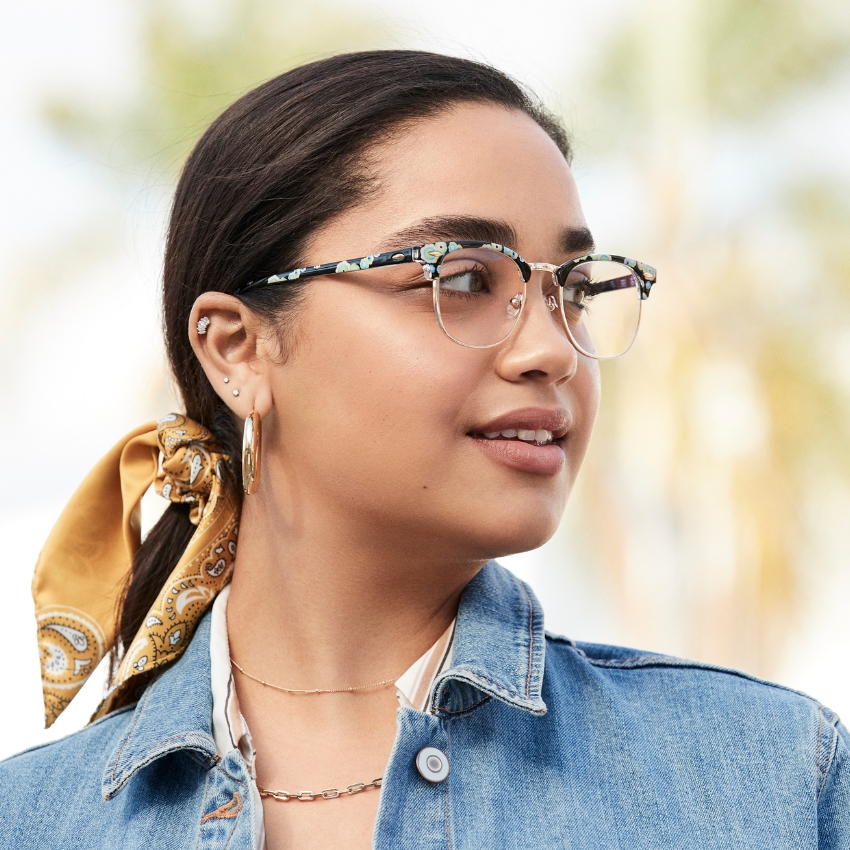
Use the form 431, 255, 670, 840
0, 51, 850, 850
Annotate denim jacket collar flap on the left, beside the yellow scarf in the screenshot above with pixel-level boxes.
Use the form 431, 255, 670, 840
102, 613, 220, 800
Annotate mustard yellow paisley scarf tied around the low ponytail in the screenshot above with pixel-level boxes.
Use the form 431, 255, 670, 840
32, 413, 239, 726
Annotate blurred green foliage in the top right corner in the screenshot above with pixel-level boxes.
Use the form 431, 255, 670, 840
591, 0, 850, 123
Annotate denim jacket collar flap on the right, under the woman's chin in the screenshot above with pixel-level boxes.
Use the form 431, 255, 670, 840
431, 561, 546, 716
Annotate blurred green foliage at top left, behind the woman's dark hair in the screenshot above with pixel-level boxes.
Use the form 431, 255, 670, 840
45, 0, 384, 179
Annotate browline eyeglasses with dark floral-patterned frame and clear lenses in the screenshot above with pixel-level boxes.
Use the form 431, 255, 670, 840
236, 241, 657, 360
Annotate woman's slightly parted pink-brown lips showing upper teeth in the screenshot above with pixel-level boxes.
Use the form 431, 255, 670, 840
468, 407, 572, 475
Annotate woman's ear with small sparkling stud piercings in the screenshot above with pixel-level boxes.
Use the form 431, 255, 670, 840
189, 292, 274, 419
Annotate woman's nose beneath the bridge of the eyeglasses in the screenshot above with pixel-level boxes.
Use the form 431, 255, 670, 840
497, 263, 579, 386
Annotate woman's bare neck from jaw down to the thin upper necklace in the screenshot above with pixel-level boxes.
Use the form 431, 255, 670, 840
227, 484, 483, 688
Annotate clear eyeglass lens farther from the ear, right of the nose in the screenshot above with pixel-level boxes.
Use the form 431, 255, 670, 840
561, 260, 641, 358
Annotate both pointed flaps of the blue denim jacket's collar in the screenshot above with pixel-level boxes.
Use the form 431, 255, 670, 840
99, 561, 546, 799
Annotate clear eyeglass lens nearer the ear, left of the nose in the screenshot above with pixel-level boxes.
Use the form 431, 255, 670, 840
435, 248, 525, 348
